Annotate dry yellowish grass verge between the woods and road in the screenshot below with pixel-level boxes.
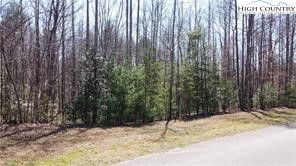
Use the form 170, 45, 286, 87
0, 108, 296, 165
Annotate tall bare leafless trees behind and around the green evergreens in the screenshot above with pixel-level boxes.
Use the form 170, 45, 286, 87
0, 0, 296, 123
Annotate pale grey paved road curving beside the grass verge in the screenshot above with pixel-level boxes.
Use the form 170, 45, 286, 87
118, 123, 296, 166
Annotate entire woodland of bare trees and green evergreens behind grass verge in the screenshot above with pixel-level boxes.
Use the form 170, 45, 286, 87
0, 0, 296, 125
